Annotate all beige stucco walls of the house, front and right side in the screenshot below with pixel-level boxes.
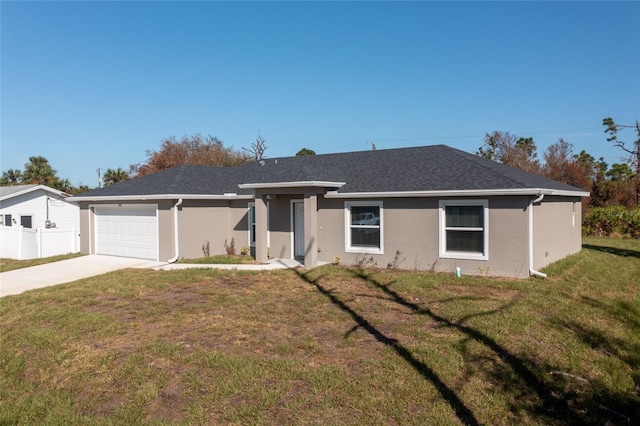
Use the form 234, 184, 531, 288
80, 195, 582, 277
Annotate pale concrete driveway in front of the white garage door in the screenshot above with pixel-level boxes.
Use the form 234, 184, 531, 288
0, 254, 166, 297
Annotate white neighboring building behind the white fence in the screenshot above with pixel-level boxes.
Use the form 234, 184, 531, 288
0, 185, 80, 229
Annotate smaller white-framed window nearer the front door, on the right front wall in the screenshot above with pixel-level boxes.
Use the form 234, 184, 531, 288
345, 201, 383, 254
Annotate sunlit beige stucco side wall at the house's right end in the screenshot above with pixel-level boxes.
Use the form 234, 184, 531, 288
533, 197, 582, 269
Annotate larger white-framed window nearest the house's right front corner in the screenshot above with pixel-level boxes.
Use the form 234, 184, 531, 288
440, 200, 489, 260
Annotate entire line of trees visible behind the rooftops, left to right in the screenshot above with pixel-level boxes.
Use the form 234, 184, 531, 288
0, 118, 640, 207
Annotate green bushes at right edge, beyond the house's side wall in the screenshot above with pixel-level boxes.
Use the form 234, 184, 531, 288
582, 206, 640, 238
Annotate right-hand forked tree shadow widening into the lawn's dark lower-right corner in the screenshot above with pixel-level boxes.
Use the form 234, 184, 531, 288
352, 270, 640, 424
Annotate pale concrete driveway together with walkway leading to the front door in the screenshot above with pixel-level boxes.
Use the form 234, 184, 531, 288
0, 254, 302, 297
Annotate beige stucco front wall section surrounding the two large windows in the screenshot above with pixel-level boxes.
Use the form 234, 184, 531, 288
318, 197, 528, 277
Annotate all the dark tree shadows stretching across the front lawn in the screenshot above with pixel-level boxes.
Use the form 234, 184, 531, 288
296, 269, 640, 425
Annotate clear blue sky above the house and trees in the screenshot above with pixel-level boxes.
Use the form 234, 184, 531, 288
0, 1, 640, 187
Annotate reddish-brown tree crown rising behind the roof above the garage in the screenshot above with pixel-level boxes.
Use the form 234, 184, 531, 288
129, 134, 249, 177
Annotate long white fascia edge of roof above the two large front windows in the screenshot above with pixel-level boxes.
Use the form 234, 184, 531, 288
325, 188, 589, 198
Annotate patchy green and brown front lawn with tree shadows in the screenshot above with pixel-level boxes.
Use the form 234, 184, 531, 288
0, 238, 640, 425
